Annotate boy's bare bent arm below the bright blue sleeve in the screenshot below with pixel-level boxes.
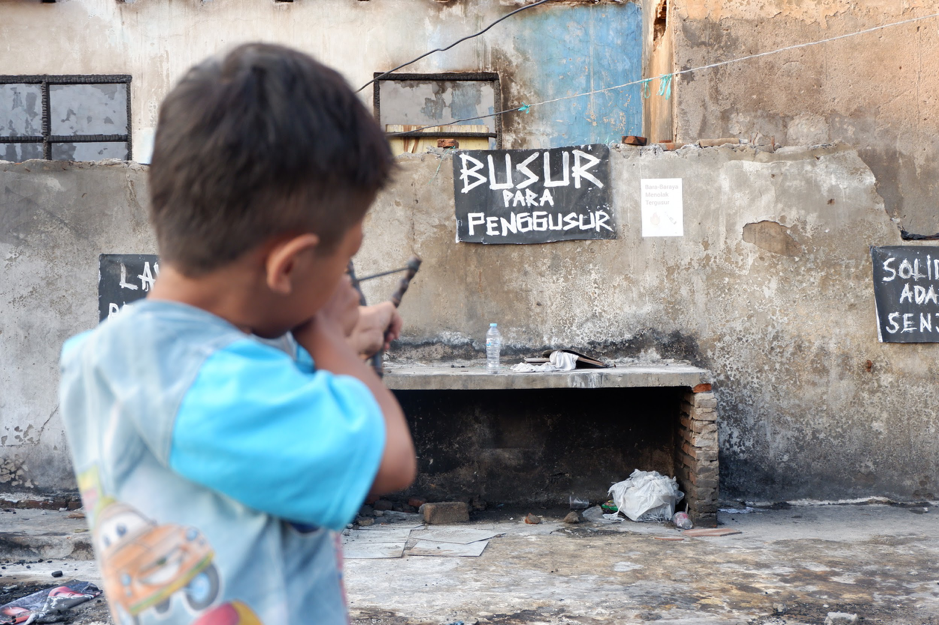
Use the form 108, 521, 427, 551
293, 279, 417, 493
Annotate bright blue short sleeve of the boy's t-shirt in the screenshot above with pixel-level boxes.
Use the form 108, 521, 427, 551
169, 340, 385, 530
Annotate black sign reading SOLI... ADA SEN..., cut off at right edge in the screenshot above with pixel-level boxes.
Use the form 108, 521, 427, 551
871, 246, 939, 343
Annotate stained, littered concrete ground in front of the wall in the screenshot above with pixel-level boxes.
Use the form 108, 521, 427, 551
0, 505, 939, 625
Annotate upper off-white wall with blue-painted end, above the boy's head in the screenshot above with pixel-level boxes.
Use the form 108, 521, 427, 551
0, 0, 642, 155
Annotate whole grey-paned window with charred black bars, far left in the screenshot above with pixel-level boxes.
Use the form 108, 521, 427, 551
0, 75, 131, 162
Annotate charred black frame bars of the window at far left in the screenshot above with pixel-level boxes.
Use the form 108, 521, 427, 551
0, 74, 134, 161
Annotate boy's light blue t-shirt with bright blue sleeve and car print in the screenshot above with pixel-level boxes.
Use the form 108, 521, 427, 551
60, 300, 385, 625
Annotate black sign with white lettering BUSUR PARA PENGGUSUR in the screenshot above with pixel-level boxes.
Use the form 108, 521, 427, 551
453, 145, 616, 243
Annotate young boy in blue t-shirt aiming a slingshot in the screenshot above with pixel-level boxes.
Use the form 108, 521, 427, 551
61, 44, 415, 625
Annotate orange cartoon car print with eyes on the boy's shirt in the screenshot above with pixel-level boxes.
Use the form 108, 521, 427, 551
94, 502, 219, 625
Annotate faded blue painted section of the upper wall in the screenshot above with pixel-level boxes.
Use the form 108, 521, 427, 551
507, 2, 644, 147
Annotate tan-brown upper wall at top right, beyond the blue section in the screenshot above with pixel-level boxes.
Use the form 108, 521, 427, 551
671, 0, 939, 235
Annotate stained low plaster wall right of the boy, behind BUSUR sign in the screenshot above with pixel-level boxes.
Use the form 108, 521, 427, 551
357, 148, 939, 500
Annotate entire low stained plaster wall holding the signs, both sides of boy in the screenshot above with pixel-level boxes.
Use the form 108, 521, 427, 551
0, 147, 939, 500
